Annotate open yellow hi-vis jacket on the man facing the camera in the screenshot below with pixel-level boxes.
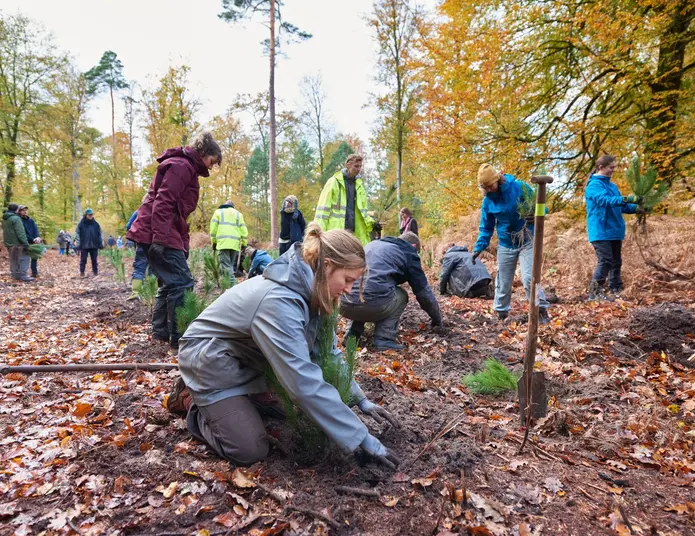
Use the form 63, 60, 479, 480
314, 171, 374, 245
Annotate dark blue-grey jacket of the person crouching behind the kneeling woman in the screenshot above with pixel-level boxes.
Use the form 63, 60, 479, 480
341, 236, 442, 324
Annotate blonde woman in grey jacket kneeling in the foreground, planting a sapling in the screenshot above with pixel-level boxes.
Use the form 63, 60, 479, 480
167, 223, 398, 467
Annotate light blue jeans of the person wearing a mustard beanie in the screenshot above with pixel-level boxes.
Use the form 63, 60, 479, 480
495, 242, 548, 313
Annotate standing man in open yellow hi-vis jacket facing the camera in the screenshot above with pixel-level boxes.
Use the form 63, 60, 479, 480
314, 154, 381, 245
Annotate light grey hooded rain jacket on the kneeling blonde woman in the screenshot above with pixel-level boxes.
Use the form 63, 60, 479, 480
179, 244, 368, 451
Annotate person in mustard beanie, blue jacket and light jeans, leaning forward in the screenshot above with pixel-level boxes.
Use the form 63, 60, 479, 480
473, 164, 550, 324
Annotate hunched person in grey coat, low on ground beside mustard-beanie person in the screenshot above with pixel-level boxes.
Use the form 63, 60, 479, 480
439, 244, 495, 298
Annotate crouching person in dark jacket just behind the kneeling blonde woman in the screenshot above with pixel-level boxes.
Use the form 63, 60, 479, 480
340, 232, 442, 350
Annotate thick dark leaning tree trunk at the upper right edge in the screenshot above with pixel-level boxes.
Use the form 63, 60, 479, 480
646, 0, 695, 186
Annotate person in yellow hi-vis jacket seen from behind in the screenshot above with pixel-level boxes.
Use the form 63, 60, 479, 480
210, 201, 249, 283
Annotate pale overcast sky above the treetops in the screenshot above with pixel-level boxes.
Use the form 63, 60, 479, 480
0, 0, 422, 162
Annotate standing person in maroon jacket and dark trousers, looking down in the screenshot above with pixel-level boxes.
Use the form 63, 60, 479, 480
126, 132, 222, 348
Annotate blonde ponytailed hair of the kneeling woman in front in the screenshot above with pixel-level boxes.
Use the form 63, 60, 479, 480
302, 222, 367, 314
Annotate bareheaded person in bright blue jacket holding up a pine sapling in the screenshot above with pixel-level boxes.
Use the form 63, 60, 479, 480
584, 154, 642, 300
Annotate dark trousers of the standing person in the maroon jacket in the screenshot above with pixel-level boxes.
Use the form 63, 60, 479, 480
143, 244, 195, 344
